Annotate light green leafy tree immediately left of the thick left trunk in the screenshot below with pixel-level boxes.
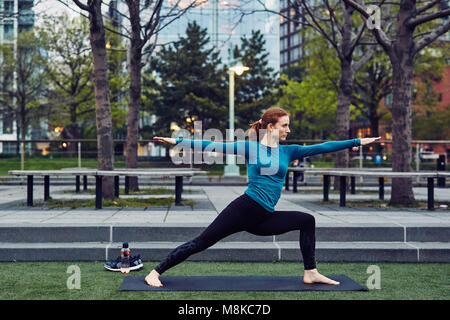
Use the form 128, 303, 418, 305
39, 15, 95, 152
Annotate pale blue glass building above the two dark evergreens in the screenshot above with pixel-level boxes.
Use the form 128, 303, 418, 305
158, 0, 280, 72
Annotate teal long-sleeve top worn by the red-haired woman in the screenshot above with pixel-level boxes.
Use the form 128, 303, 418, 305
176, 138, 361, 212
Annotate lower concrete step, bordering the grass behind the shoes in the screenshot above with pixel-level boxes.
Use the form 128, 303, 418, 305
0, 241, 450, 263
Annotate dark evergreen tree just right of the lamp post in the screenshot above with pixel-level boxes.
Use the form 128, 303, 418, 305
233, 30, 276, 128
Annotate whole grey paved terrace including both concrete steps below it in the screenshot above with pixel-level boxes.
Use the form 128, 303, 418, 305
0, 184, 450, 262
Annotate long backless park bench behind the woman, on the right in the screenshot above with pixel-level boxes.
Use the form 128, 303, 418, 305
287, 167, 450, 210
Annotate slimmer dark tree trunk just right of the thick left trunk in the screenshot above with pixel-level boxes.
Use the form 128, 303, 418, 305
125, 0, 142, 191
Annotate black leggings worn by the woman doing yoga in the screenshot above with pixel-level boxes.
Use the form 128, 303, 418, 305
155, 193, 316, 274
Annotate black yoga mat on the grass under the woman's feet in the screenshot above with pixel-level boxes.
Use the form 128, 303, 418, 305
119, 275, 367, 291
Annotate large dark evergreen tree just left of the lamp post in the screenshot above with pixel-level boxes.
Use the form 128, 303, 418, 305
151, 21, 228, 134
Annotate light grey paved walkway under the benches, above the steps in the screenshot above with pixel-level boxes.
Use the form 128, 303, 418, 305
0, 185, 450, 226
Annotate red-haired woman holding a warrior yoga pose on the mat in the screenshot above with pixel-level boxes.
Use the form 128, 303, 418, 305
145, 108, 380, 287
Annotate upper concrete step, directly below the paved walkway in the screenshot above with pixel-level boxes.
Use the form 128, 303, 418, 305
0, 223, 450, 243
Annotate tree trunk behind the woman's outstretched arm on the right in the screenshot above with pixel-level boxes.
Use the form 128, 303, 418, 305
334, 59, 354, 189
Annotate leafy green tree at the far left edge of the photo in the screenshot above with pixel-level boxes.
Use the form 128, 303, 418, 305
0, 31, 47, 146
